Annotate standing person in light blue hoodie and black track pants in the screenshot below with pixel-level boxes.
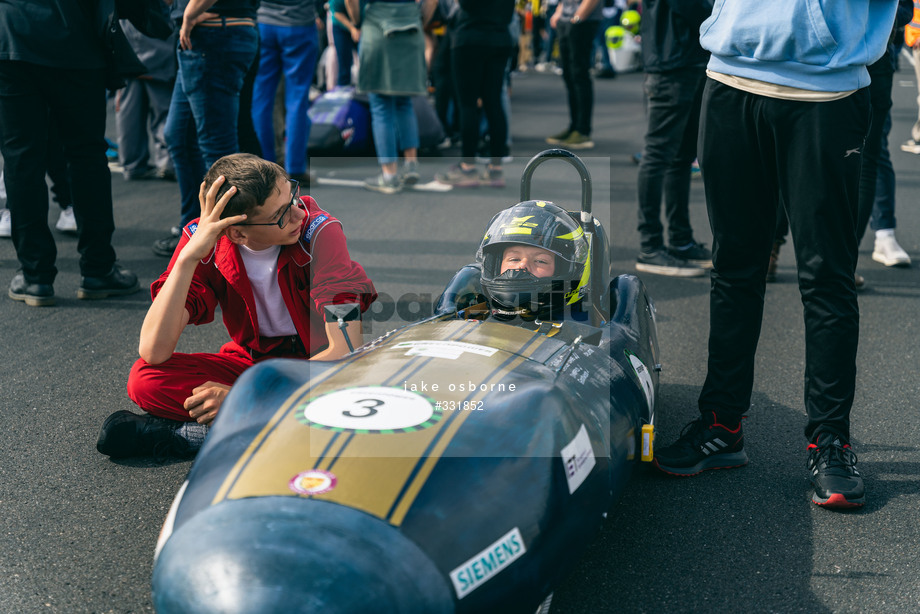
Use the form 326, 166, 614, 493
654, 0, 897, 509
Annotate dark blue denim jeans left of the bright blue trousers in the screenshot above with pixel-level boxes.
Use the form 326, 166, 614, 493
165, 26, 259, 226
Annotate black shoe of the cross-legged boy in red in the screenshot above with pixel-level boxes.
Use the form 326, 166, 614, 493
96, 409, 198, 458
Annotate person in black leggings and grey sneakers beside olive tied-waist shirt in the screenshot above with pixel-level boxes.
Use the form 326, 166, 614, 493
437, 0, 514, 188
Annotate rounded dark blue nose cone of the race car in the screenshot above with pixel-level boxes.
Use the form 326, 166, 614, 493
153, 497, 454, 614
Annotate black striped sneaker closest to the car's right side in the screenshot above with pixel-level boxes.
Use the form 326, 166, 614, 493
654, 412, 748, 477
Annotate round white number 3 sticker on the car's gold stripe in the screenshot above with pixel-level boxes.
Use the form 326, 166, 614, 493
297, 386, 441, 434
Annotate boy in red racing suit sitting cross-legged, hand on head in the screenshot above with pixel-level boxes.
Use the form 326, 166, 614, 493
96, 154, 377, 458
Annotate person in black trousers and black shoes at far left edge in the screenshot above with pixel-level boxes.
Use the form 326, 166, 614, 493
0, 0, 139, 307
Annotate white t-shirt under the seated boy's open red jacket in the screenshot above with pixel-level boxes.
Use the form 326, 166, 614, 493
239, 245, 297, 337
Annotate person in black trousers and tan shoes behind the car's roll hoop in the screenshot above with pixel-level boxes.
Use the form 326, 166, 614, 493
546, 0, 603, 149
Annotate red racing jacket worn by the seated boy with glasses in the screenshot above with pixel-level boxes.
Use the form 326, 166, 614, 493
150, 196, 377, 358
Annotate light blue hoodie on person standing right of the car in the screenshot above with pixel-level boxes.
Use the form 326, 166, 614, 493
700, 0, 898, 92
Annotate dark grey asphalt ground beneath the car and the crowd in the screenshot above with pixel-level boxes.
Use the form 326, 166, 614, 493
0, 64, 920, 614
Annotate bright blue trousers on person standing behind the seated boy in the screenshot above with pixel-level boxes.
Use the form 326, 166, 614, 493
252, 23, 319, 174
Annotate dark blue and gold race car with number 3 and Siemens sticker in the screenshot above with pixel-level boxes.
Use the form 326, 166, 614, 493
152, 149, 659, 614
